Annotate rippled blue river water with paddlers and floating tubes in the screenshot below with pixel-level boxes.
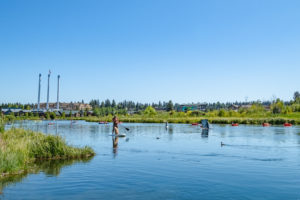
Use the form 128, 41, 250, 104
0, 121, 300, 200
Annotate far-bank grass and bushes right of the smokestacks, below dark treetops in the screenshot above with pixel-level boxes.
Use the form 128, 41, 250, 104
75, 97, 300, 125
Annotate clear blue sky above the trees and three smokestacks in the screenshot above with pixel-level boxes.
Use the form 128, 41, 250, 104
0, 0, 300, 103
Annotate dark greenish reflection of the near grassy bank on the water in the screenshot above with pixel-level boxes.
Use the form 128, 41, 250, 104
0, 157, 93, 197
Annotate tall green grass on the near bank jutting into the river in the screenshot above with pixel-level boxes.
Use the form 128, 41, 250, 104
0, 128, 95, 179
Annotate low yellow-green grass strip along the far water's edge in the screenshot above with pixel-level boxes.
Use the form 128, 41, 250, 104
4, 111, 300, 125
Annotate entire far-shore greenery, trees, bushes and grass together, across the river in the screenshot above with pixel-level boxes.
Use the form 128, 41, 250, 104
2, 92, 300, 125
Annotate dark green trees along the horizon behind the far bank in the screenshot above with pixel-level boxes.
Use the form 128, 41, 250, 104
0, 91, 300, 116
